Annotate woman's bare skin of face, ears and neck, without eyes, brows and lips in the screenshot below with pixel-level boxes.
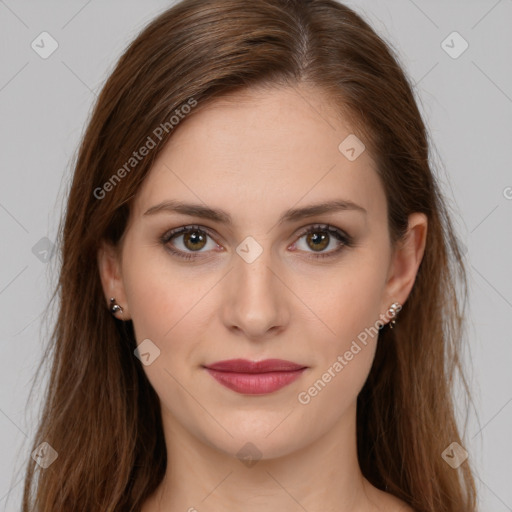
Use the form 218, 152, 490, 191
98, 87, 427, 512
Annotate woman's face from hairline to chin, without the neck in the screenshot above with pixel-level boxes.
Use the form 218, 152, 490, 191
100, 83, 426, 458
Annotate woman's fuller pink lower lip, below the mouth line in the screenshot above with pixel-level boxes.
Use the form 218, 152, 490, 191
206, 368, 306, 395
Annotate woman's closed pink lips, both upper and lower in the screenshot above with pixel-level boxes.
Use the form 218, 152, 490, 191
205, 359, 307, 395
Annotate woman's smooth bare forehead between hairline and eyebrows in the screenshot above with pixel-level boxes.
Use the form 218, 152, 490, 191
131, 87, 385, 226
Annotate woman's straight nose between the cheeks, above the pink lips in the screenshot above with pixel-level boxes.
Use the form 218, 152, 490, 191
222, 248, 291, 341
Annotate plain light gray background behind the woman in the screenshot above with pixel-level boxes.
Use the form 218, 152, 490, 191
0, 0, 512, 512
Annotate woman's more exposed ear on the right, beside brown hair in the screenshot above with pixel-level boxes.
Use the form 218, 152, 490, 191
381, 213, 428, 311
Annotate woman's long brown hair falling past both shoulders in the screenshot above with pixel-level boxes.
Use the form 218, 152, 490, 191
23, 0, 476, 512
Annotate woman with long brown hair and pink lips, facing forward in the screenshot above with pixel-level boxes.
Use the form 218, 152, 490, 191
23, 0, 476, 512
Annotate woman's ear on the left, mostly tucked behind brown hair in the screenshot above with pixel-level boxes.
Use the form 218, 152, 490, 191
97, 240, 130, 320
